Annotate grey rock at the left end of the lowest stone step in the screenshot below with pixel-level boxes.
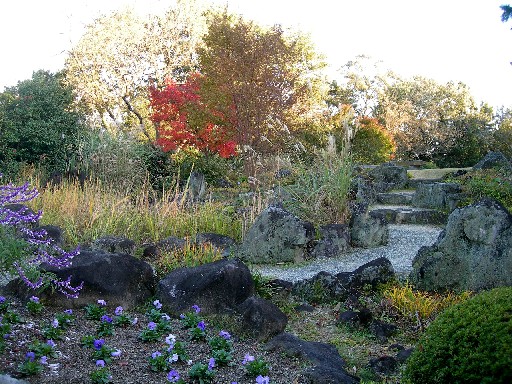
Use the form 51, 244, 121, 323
350, 203, 389, 248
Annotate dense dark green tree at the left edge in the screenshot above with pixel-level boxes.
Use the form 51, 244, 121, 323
0, 70, 81, 174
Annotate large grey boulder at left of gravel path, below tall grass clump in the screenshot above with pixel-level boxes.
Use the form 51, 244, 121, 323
238, 206, 315, 264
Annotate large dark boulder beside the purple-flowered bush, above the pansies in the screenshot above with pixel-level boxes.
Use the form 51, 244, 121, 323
39, 250, 156, 308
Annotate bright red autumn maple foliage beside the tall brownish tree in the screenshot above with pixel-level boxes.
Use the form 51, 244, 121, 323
149, 74, 237, 158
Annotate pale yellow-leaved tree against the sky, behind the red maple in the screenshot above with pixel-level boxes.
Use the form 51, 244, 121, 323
65, 0, 204, 139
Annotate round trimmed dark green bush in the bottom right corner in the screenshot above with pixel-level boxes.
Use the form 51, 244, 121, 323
404, 287, 512, 384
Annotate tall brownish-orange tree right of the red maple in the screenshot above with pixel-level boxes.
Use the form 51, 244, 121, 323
198, 11, 324, 153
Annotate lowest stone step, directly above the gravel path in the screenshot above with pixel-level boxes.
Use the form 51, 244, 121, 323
369, 205, 448, 226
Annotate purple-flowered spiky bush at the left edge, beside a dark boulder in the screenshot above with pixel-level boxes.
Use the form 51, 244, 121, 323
0, 173, 82, 298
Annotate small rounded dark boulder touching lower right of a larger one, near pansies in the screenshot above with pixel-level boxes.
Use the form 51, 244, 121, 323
237, 296, 288, 340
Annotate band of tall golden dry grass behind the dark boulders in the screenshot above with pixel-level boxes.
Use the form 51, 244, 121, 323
26, 180, 242, 246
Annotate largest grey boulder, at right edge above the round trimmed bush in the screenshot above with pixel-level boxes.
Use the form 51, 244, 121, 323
411, 199, 512, 291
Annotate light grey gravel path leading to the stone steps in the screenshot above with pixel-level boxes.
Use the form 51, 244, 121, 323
254, 225, 442, 283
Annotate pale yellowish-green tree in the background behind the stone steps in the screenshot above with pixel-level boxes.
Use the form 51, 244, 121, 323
377, 76, 478, 161
